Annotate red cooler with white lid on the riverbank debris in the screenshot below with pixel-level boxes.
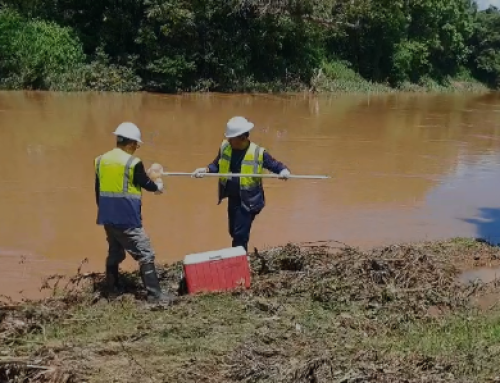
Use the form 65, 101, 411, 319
184, 246, 250, 294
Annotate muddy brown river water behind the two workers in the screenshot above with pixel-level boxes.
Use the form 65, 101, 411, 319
0, 92, 500, 298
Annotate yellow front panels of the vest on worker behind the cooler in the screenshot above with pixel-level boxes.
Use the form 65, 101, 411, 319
219, 140, 264, 190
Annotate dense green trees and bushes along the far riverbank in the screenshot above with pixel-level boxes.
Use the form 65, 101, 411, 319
0, 0, 500, 92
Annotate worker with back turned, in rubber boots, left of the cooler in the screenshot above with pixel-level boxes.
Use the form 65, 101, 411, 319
95, 122, 174, 303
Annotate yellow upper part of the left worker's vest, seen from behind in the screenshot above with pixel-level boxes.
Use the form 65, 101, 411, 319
95, 148, 141, 199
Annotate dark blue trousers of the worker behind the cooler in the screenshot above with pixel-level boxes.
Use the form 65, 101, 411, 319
227, 197, 258, 251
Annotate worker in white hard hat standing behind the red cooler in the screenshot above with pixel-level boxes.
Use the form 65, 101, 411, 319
193, 117, 290, 251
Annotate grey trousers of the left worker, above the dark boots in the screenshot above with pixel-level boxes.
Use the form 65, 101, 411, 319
104, 225, 155, 266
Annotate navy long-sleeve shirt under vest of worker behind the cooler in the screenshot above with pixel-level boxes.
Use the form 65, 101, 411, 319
208, 145, 288, 197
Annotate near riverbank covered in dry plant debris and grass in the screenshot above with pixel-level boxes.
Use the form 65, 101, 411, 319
0, 239, 500, 383
